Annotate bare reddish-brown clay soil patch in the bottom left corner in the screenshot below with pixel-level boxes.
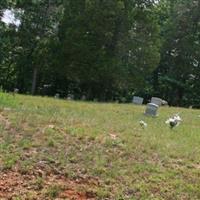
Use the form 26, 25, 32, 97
0, 171, 95, 200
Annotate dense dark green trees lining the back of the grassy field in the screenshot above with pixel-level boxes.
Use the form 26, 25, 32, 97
0, 0, 200, 107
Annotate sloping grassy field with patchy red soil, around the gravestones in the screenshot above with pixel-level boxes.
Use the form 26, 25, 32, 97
0, 93, 200, 200
